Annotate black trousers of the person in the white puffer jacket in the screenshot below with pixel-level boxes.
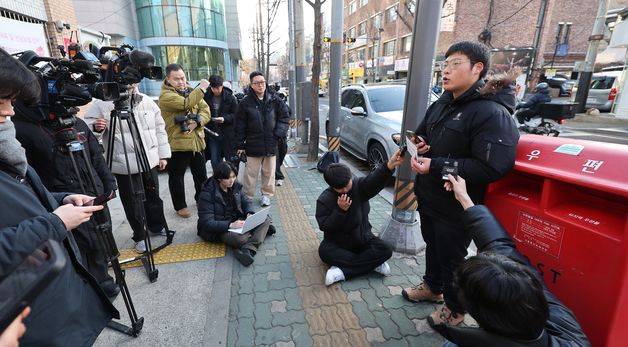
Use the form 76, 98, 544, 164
115, 168, 167, 242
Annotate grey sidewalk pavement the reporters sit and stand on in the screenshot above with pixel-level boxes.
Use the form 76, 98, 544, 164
96, 148, 458, 347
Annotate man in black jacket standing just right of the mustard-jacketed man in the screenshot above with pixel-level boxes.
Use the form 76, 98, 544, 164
204, 75, 238, 170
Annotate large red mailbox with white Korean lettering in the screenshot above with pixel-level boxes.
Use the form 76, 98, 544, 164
485, 135, 628, 346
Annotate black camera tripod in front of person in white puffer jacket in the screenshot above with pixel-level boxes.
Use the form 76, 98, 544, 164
107, 93, 175, 282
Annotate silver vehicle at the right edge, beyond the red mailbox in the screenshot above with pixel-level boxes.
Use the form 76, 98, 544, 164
572, 71, 622, 112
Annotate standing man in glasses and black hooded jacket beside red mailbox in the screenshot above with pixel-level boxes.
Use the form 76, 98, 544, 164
402, 42, 519, 326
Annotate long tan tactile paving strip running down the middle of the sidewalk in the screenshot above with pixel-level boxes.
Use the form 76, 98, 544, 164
276, 177, 370, 347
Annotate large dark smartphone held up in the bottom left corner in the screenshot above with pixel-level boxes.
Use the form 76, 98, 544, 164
0, 240, 67, 332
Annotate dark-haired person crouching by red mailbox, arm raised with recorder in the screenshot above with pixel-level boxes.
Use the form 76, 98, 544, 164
434, 175, 591, 347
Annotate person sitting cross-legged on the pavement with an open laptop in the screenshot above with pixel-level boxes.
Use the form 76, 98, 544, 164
197, 161, 275, 266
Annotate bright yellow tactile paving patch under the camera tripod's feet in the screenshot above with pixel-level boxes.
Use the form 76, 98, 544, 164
119, 241, 227, 269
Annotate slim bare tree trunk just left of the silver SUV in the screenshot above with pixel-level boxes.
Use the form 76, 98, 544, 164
307, 0, 322, 161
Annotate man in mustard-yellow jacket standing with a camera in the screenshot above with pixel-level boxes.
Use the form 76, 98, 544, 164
159, 64, 211, 218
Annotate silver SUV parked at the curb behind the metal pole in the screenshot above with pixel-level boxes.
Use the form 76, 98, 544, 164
326, 83, 438, 169
